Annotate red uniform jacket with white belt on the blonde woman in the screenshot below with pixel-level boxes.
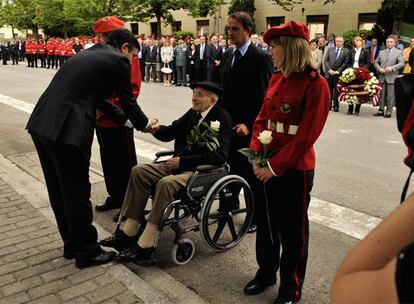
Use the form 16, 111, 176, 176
250, 69, 331, 176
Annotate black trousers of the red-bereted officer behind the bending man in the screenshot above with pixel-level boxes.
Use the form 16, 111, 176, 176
96, 127, 137, 207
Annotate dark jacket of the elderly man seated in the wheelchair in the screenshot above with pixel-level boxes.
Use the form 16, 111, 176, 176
154, 105, 233, 174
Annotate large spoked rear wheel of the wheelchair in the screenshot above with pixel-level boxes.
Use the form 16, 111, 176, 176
200, 175, 253, 251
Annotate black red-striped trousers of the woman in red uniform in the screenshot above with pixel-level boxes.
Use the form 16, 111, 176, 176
255, 170, 314, 301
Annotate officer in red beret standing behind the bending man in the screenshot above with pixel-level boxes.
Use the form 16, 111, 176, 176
93, 16, 145, 221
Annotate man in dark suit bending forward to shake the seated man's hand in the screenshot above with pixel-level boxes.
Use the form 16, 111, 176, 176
26, 29, 158, 268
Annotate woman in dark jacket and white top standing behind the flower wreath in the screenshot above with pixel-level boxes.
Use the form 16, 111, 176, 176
346, 36, 370, 116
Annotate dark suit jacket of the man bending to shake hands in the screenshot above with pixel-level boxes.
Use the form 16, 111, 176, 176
26, 44, 148, 152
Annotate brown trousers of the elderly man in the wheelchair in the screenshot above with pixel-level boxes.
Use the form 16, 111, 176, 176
122, 162, 193, 226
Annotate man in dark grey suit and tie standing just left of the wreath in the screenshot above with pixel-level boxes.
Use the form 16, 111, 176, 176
325, 36, 349, 112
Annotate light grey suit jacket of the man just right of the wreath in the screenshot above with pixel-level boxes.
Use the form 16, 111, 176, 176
374, 48, 404, 84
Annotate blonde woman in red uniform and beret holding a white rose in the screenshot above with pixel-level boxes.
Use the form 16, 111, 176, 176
244, 21, 330, 303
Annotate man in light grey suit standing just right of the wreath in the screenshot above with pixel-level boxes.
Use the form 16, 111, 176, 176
373, 36, 404, 118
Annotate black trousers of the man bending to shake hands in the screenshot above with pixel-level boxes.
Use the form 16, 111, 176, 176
32, 134, 100, 259
